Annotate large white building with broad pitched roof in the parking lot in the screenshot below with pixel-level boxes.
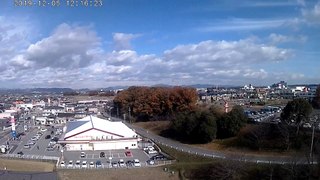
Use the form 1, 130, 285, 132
59, 116, 139, 151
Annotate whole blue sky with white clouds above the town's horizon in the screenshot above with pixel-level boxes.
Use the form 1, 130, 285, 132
0, 0, 320, 89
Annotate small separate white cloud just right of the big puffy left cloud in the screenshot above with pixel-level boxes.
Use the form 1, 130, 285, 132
113, 33, 140, 50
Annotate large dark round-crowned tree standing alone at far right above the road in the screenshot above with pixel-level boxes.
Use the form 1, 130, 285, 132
281, 98, 312, 135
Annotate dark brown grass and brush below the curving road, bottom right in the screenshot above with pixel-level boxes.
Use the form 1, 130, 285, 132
160, 145, 320, 180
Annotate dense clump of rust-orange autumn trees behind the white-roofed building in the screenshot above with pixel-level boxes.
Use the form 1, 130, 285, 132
114, 86, 198, 121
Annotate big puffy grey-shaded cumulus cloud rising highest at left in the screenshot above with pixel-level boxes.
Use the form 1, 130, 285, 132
24, 24, 100, 69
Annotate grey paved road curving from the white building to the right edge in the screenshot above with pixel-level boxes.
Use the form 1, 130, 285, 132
113, 118, 317, 164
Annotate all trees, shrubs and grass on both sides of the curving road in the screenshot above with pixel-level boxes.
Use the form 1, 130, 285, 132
114, 87, 320, 179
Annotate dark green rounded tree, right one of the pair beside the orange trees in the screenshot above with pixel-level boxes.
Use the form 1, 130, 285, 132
217, 106, 248, 138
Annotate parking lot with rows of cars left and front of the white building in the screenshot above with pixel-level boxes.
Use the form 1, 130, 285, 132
0, 119, 172, 169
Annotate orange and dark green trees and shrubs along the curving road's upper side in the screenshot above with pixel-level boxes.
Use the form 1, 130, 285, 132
114, 87, 320, 154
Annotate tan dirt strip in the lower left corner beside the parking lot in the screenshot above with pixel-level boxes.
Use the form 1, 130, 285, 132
0, 159, 55, 172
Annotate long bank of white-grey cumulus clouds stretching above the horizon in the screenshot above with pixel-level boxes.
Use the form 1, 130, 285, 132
0, 19, 312, 88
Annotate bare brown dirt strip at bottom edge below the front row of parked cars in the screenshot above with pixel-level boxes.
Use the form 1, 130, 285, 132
58, 167, 179, 180
